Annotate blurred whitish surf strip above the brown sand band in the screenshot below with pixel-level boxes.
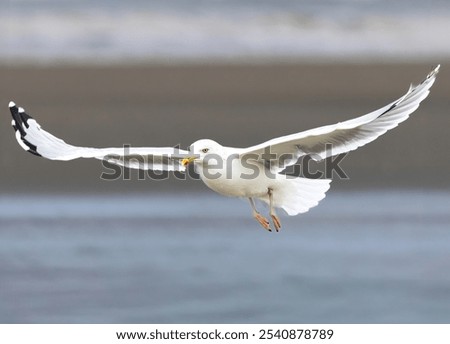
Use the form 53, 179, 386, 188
0, 0, 450, 64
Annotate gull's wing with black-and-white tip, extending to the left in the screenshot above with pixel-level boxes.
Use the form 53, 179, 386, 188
9, 102, 188, 171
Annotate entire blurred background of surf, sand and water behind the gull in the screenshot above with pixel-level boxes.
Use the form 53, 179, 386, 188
0, 0, 450, 323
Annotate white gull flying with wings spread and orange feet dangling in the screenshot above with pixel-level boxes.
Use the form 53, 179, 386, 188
9, 66, 439, 231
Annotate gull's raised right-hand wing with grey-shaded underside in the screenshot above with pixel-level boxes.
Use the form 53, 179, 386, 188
240, 66, 439, 171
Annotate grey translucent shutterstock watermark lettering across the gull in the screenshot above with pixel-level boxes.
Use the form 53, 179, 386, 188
100, 144, 349, 181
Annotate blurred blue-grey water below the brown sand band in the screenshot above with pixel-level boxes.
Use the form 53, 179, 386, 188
0, 191, 450, 323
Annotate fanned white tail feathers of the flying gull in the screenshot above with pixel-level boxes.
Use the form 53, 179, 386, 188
263, 174, 331, 216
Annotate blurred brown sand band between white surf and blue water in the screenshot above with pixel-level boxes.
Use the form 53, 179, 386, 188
0, 63, 450, 192
